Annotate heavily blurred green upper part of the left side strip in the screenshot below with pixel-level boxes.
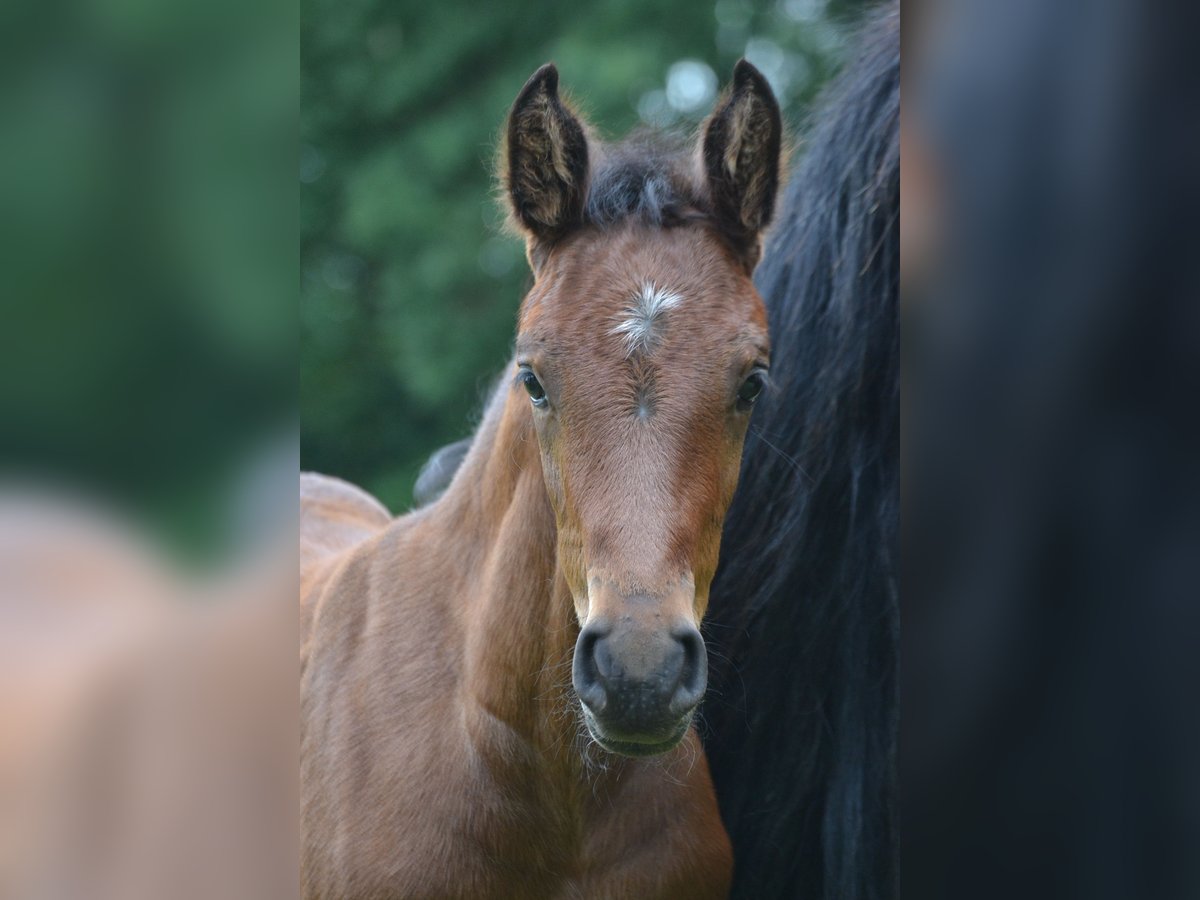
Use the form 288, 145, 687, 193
0, 0, 299, 564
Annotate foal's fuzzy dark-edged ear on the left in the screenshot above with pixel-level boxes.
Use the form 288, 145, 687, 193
504, 62, 588, 242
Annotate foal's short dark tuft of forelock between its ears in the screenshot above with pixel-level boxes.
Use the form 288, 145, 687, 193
583, 131, 709, 228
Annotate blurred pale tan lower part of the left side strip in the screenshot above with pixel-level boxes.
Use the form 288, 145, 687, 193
0, 493, 299, 900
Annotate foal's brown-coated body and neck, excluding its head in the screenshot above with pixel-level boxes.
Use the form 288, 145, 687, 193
301, 386, 731, 900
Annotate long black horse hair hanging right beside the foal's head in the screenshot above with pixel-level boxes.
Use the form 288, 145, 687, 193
703, 4, 900, 900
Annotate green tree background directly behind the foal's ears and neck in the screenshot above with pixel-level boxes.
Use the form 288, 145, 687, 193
300, 0, 866, 512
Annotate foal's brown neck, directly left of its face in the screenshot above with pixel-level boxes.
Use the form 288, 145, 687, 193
445, 376, 578, 766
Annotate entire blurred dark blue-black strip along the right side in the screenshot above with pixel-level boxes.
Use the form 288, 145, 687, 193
901, 0, 1200, 900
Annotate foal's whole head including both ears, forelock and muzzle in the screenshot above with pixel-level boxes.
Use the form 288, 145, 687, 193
504, 61, 780, 756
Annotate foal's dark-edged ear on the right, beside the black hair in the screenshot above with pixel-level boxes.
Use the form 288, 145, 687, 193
702, 59, 784, 268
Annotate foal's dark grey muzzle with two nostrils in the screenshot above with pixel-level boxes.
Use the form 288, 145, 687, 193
572, 620, 708, 740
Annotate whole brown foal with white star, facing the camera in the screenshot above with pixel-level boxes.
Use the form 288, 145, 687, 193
301, 61, 781, 898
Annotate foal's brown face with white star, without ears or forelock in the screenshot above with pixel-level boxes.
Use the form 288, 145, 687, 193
514, 224, 769, 755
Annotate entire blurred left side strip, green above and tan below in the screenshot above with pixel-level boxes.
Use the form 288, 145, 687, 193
0, 0, 298, 900
